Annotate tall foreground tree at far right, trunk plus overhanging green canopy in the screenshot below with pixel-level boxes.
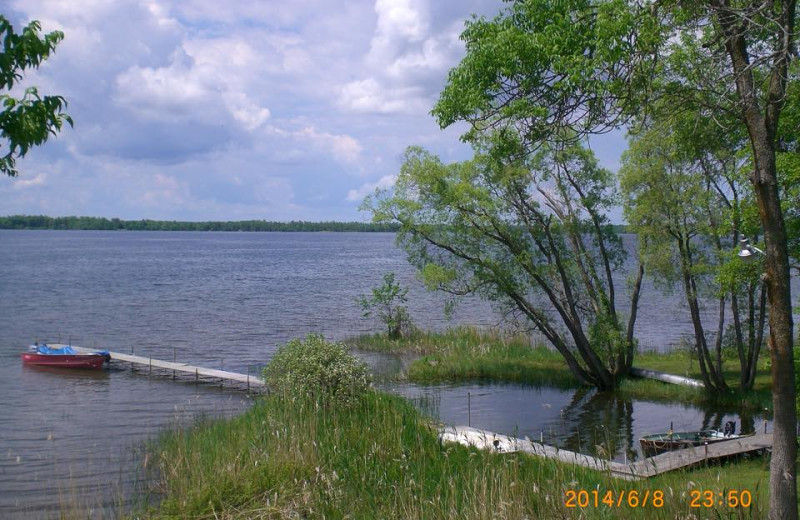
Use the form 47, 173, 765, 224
434, 0, 797, 518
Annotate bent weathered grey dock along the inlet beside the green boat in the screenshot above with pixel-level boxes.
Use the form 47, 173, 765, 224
439, 426, 772, 480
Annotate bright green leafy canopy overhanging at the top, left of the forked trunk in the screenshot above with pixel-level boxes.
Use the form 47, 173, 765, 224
433, 0, 668, 153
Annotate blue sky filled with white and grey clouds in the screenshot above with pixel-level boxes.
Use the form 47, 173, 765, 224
0, 0, 624, 221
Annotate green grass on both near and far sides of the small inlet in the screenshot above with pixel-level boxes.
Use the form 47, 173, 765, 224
136, 329, 780, 519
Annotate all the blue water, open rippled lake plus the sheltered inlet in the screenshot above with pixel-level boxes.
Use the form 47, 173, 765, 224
0, 230, 788, 518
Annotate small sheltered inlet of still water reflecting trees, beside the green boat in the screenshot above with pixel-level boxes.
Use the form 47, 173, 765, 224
381, 374, 763, 461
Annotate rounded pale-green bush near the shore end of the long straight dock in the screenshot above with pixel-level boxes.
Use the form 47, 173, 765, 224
264, 334, 370, 405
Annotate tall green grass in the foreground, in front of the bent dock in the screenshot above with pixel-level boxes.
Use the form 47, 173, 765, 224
149, 391, 768, 519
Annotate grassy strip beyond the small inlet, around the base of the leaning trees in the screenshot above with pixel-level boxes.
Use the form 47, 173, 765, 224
348, 327, 772, 411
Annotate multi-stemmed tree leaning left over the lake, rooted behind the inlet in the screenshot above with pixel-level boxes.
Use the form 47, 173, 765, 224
364, 145, 643, 389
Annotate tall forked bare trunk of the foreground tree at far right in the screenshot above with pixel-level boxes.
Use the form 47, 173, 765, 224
710, 0, 797, 520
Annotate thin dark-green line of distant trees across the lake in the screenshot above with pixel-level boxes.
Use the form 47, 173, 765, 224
0, 215, 400, 231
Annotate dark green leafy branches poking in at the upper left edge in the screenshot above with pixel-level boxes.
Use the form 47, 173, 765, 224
0, 15, 73, 177
